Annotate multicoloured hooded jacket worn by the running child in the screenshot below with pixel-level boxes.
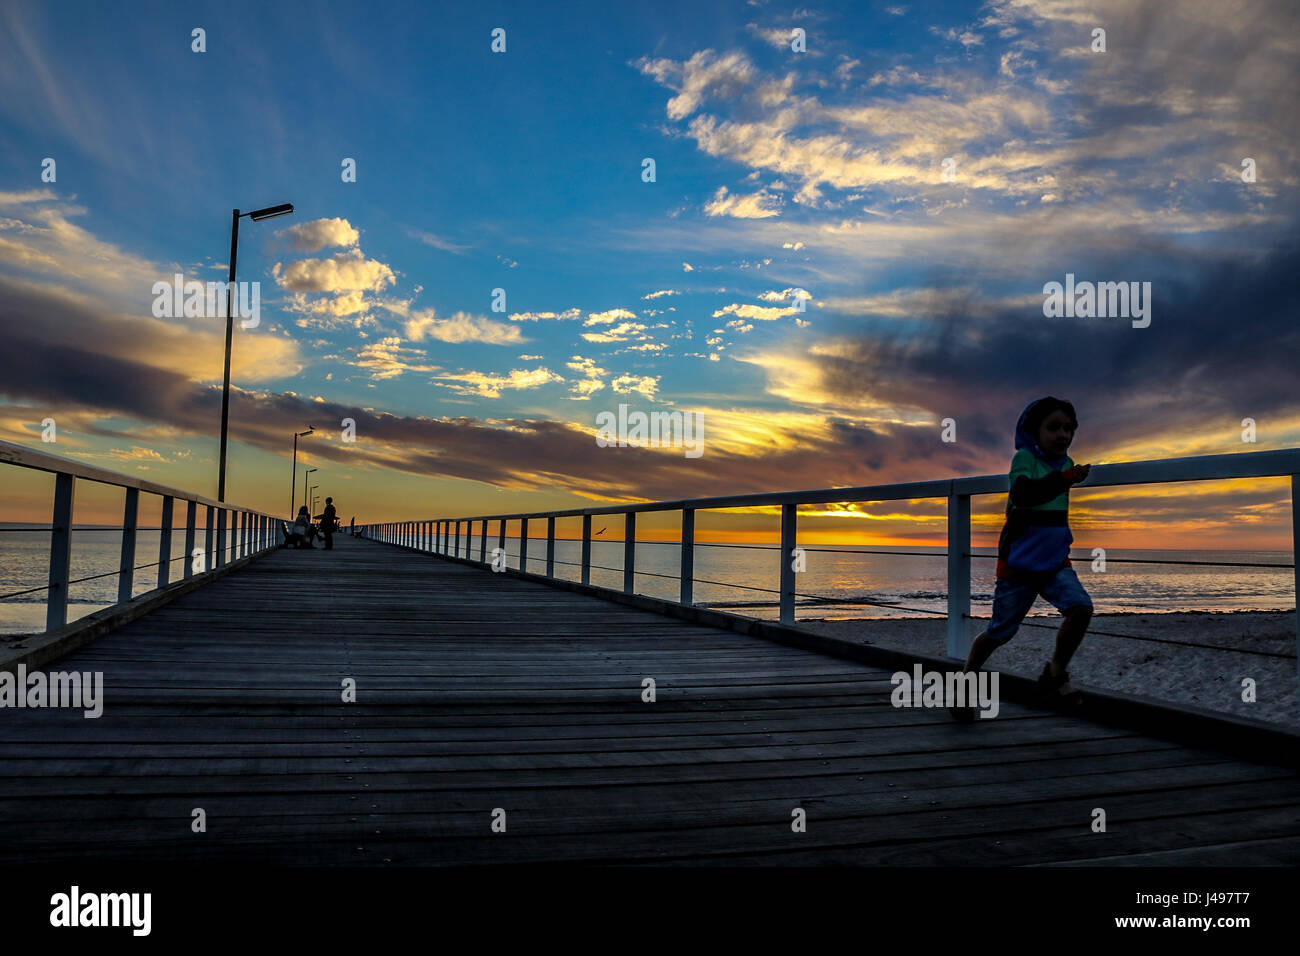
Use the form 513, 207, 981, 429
997, 399, 1078, 583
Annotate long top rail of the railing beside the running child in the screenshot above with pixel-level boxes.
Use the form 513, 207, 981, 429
419, 449, 1300, 522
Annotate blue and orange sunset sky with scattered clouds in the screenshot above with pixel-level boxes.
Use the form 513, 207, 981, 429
0, 0, 1300, 549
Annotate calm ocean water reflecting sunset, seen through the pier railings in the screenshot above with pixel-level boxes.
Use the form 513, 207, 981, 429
0, 525, 1295, 633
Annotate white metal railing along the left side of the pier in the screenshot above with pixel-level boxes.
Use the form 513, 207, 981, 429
0, 441, 281, 631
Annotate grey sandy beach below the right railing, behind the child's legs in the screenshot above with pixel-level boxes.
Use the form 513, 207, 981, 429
800, 611, 1300, 727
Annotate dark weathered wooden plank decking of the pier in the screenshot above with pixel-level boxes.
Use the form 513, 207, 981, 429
0, 537, 1300, 865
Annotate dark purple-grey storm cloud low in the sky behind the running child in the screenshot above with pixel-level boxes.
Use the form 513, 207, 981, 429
822, 239, 1300, 465
